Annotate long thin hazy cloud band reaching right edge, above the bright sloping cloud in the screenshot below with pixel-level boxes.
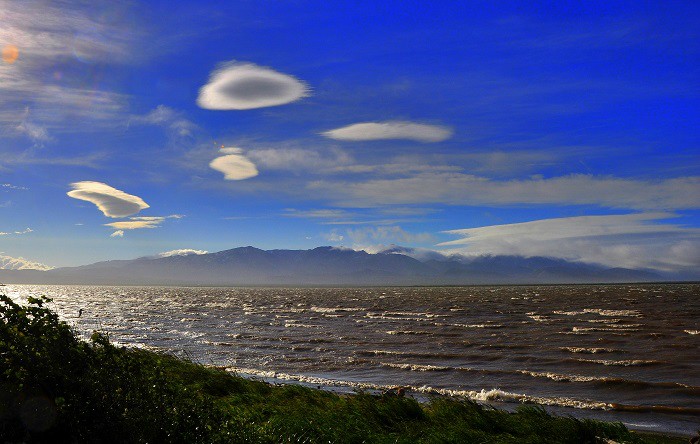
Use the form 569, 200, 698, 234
307, 173, 700, 210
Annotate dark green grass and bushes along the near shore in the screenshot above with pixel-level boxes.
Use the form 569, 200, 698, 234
0, 295, 684, 443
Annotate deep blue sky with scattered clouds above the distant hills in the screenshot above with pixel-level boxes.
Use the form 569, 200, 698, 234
0, 1, 700, 271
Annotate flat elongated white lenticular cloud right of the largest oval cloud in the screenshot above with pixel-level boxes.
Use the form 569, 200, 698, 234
321, 121, 453, 142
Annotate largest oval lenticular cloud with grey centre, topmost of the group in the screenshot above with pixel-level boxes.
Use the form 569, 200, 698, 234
197, 62, 309, 110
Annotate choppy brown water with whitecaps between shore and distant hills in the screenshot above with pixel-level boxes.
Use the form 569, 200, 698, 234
4, 284, 700, 434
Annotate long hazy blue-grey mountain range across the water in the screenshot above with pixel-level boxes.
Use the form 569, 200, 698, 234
0, 247, 676, 286
